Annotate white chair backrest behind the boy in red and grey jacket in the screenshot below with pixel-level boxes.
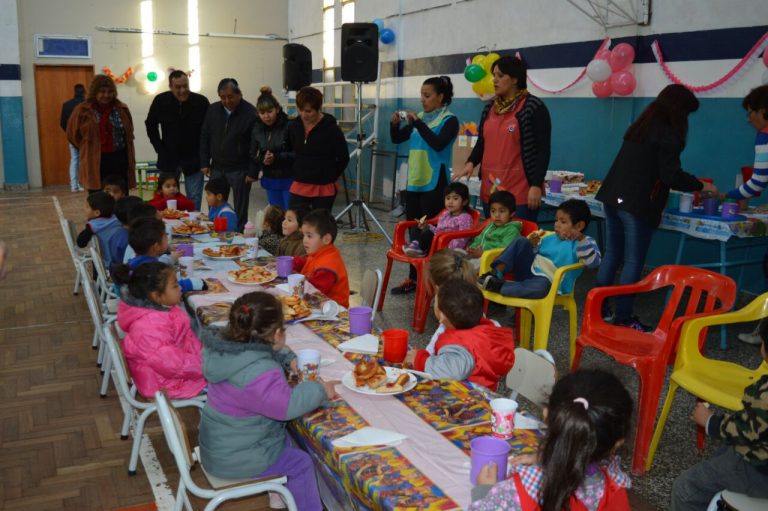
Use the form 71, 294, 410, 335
506, 348, 557, 407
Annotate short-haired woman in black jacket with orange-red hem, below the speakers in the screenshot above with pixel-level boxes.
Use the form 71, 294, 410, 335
283, 87, 349, 211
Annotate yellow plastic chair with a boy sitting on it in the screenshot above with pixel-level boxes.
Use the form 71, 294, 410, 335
480, 248, 584, 359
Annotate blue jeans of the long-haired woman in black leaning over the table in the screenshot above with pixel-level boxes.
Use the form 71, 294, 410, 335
596, 205, 654, 322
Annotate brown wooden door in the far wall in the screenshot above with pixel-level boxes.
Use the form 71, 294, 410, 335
35, 65, 93, 186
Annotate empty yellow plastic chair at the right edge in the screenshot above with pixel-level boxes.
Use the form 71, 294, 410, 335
645, 293, 768, 470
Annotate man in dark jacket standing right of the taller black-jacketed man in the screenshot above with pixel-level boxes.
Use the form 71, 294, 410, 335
200, 78, 256, 231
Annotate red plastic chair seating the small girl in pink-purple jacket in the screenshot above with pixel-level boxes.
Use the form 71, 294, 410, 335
379, 208, 480, 333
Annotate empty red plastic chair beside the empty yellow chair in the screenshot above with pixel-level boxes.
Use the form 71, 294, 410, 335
571, 265, 736, 474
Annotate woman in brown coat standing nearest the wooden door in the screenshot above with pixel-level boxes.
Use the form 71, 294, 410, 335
67, 75, 136, 193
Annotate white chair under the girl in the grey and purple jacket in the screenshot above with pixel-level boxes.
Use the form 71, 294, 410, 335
155, 391, 296, 511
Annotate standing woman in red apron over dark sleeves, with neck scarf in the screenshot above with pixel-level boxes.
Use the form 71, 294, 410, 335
453, 57, 552, 220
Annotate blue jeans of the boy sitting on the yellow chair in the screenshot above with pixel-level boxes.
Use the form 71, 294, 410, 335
491, 238, 552, 298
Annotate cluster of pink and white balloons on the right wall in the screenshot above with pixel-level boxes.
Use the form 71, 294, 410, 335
587, 43, 637, 98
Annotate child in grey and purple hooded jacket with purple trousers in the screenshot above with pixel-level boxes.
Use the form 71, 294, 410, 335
199, 291, 336, 511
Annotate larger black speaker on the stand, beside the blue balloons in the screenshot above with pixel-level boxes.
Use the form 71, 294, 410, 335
341, 23, 379, 82
